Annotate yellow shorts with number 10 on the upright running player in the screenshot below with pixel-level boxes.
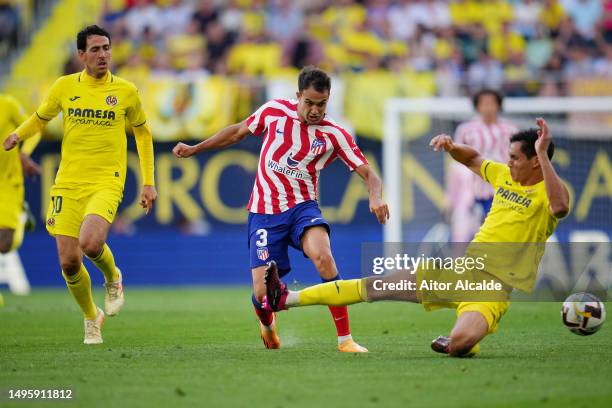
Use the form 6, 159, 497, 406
46, 187, 123, 238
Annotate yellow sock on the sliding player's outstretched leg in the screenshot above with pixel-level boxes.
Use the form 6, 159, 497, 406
296, 279, 366, 306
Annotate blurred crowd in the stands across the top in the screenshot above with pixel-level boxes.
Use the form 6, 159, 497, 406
73, 0, 612, 96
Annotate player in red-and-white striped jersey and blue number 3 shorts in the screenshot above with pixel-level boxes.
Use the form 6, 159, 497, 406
173, 66, 389, 352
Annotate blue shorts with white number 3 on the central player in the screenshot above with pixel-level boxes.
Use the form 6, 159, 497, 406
248, 200, 330, 276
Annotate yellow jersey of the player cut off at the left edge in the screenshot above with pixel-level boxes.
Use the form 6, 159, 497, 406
0, 94, 38, 187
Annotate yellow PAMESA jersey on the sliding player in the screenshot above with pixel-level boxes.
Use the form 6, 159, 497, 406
467, 160, 559, 292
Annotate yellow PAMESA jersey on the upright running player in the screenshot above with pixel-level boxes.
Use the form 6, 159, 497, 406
36, 70, 146, 195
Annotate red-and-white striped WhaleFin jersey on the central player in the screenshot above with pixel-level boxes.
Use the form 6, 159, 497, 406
246, 99, 367, 214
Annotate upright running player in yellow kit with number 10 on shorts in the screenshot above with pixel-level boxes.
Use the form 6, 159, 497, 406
4, 26, 157, 344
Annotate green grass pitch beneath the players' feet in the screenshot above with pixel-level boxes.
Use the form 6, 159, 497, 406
0, 286, 612, 408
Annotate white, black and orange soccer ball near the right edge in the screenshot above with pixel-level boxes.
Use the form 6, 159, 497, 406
561, 292, 606, 336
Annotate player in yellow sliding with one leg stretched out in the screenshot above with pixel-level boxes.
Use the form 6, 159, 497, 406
265, 118, 569, 356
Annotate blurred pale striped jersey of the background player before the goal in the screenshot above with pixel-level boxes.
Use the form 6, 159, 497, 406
455, 118, 518, 200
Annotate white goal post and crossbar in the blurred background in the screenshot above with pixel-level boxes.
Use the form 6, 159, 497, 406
382, 97, 612, 242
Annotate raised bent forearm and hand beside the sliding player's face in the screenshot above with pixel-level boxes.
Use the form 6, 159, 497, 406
535, 118, 569, 218
